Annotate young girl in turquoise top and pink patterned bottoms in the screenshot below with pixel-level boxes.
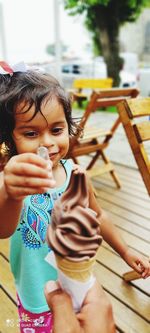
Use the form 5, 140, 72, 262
0, 66, 150, 333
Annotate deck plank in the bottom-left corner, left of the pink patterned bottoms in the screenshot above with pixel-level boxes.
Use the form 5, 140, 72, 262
0, 289, 19, 333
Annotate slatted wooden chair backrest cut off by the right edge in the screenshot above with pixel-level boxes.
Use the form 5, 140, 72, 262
117, 97, 150, 195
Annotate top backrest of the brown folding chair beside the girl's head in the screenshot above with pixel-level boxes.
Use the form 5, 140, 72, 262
80, 88, 139, 128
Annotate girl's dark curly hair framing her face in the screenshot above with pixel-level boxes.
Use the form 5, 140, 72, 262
0, 70, 76, 158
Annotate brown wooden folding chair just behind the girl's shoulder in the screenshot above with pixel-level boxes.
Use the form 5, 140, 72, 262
68, 88, 139, 188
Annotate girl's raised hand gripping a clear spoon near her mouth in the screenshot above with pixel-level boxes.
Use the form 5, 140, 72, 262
3, 153, 55, 200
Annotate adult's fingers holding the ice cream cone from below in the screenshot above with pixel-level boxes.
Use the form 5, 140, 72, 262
45, 281, 116, 333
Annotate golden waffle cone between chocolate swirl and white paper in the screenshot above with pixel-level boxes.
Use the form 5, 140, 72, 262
55, 254, 95, 282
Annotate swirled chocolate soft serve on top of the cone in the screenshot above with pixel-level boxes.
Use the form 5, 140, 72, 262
47, 172, 102, 262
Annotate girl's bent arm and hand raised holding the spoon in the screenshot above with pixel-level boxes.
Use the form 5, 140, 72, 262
0, 153, 55, 238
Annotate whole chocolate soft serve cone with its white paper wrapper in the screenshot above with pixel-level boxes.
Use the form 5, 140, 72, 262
47, 172, 102, 312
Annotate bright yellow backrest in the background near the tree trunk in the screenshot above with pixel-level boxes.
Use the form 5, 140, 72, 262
73, 77, 113, 90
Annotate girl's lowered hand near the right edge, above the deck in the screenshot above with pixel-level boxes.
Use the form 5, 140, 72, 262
123, 248, 150, 279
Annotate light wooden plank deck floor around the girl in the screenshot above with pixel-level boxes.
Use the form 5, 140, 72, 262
0, 165, 150, 333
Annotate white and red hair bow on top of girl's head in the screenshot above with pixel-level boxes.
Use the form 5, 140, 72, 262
0, 61, 27, 75
